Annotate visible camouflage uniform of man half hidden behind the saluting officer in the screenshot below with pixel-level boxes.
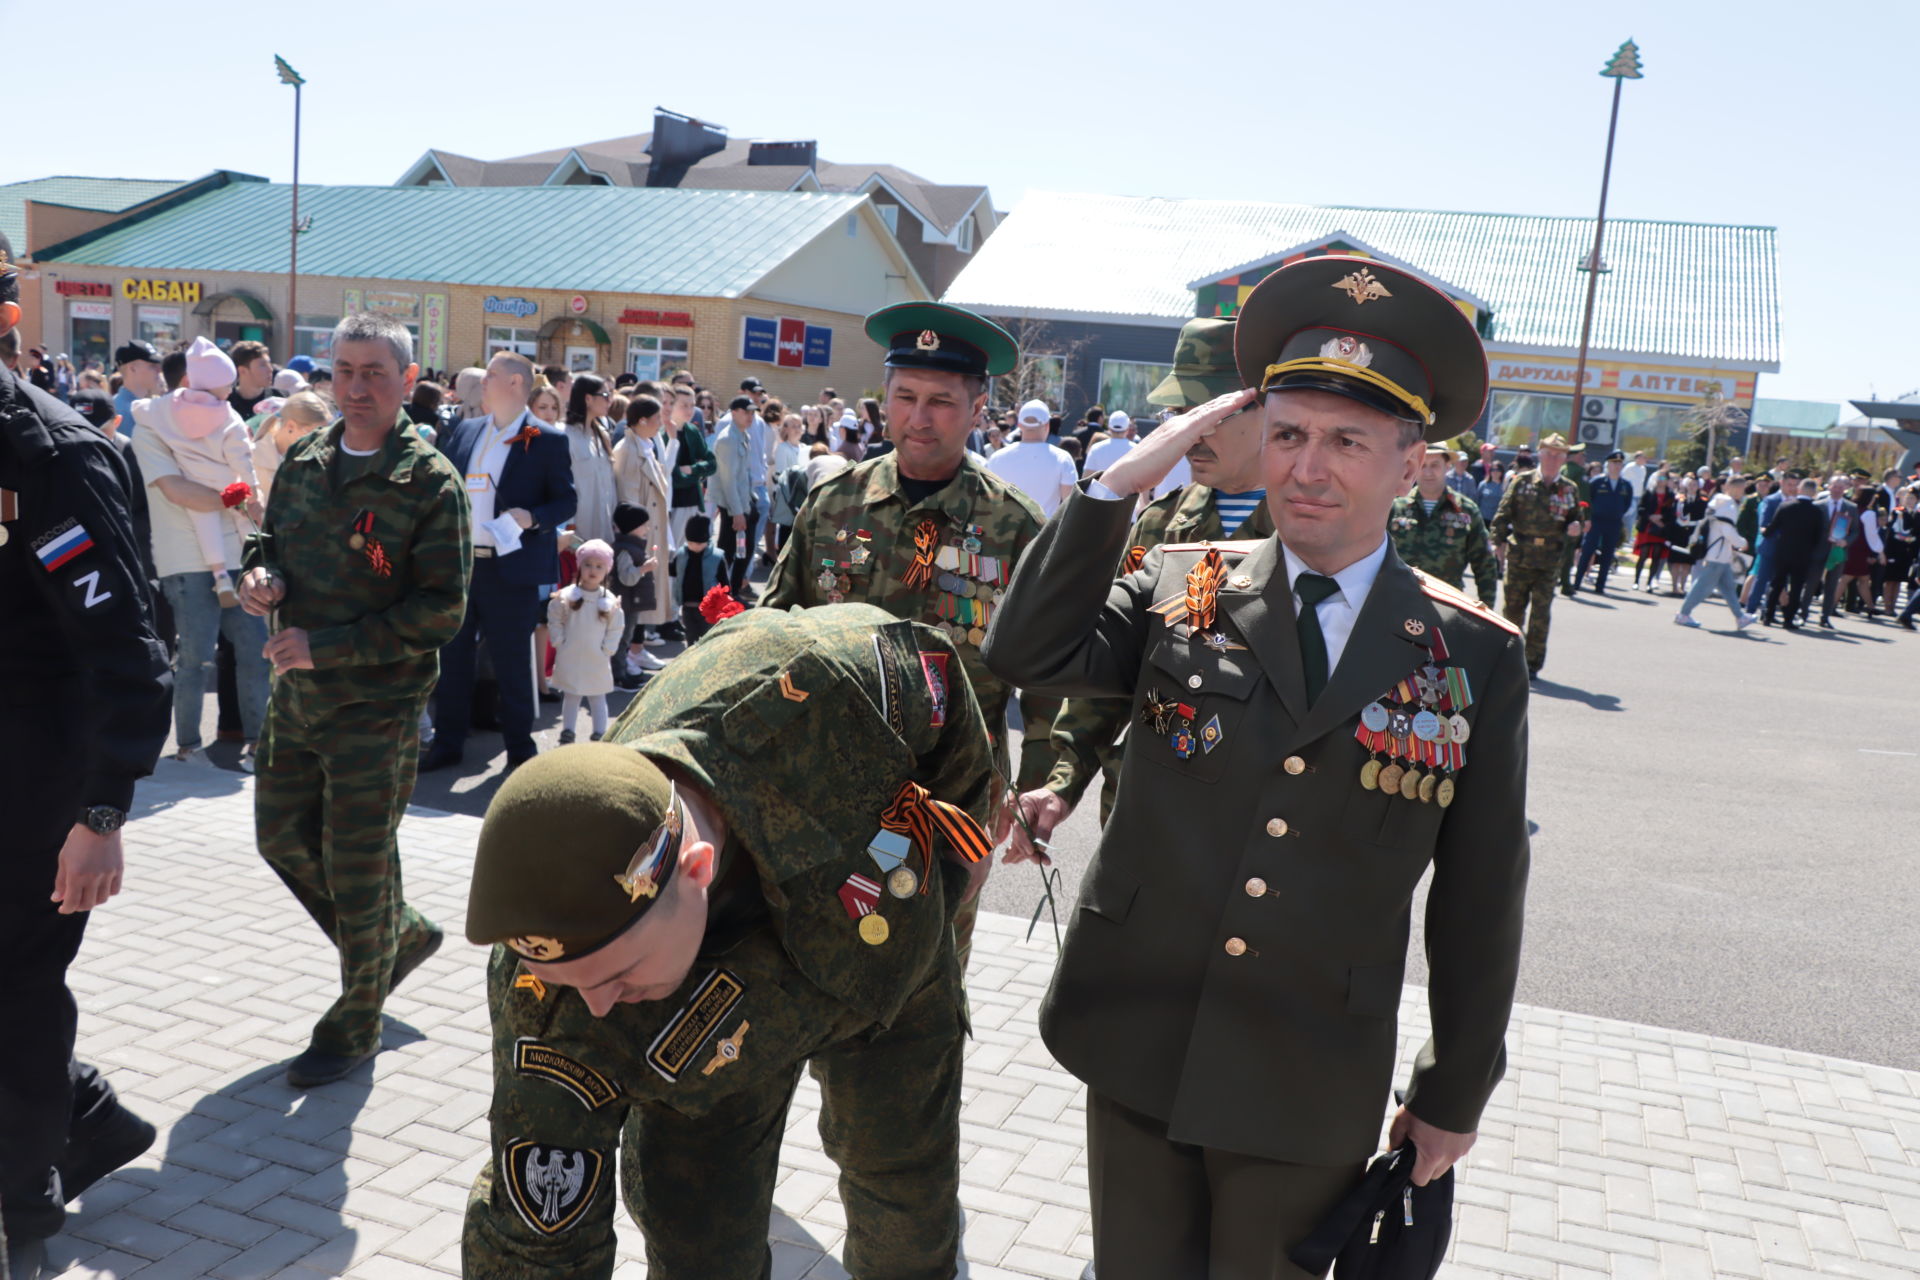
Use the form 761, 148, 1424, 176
1046, 484, 1273, 825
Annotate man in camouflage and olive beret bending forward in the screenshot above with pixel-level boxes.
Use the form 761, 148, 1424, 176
463, 604, 996, 1280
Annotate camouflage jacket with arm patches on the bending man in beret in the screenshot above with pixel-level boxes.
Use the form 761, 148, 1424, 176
463, 604, 993, 1280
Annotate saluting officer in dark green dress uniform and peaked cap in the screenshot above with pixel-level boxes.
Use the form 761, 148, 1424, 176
987, 257, 1528, 1280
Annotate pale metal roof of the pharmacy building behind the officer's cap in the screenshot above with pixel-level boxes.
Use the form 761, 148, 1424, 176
945, 192, 1780, 368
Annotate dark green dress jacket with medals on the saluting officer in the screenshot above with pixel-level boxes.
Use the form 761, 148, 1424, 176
985, 493, 1528, 1165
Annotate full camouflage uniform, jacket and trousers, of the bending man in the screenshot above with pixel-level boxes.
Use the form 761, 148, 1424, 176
463, 604, 995, 1280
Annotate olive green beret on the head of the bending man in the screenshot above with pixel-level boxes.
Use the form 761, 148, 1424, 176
467, 743, 685, 961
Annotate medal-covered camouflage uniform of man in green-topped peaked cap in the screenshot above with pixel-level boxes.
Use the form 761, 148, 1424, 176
760, 453, 1060, 965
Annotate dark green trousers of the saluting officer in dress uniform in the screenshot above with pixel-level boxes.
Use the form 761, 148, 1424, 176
1087, 1090, 1367, 1280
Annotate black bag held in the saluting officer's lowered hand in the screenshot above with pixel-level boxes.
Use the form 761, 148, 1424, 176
1286, 1140, 1453, 1280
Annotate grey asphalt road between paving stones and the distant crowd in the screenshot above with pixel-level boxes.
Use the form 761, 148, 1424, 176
187, 571, 1920, 1069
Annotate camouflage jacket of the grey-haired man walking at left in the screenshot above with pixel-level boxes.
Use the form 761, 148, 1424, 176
246, 416, 472, 706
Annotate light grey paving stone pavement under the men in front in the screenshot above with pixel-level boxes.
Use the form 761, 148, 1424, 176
41, 762, 1920, 1280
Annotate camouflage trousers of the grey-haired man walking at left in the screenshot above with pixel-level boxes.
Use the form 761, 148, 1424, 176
253, 676, 432, 1055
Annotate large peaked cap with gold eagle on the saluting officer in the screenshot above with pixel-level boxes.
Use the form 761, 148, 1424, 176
1235, 255, 1486, 441
